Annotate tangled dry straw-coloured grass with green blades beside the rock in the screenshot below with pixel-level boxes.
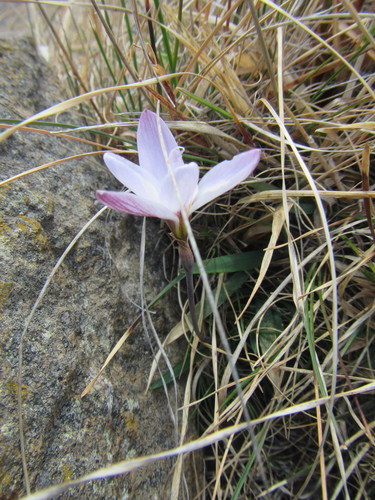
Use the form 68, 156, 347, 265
1, 0, 375, 499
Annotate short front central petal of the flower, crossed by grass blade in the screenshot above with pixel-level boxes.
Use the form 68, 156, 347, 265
160, 162, 199, 213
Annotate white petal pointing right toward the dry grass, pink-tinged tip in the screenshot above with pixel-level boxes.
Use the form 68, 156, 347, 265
192, 149, 260, 211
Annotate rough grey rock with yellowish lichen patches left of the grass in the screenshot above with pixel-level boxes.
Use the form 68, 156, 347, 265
0, 40, 194, 500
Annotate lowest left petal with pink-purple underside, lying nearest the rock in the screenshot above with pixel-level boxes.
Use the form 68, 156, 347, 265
96, 191, 178, 223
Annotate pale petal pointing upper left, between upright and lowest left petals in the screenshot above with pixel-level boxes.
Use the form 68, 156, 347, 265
103, 153, 158, 201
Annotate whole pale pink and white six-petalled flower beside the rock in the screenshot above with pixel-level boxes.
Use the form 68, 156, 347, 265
96, 110, 260, 239
